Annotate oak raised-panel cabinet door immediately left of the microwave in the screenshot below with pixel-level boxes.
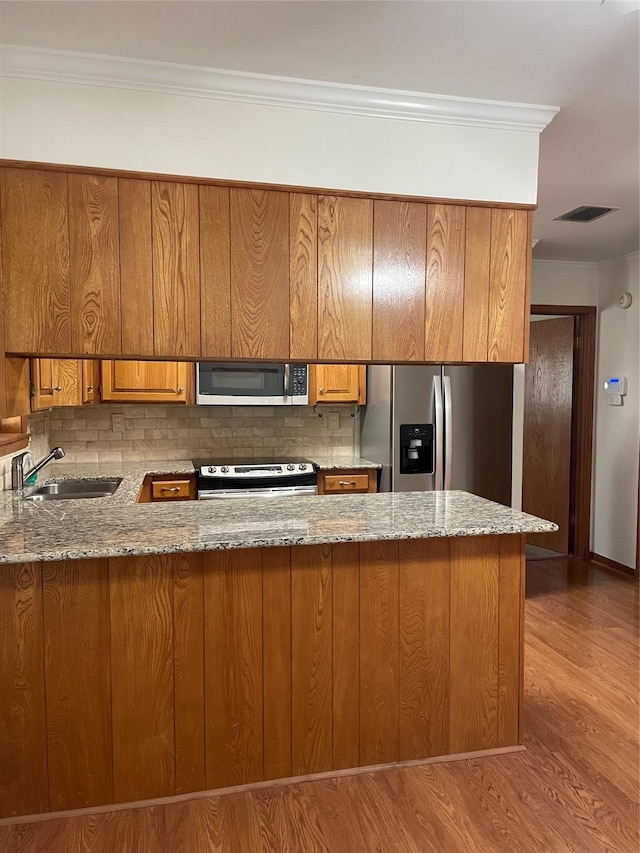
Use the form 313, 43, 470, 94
101, 361, 194, 403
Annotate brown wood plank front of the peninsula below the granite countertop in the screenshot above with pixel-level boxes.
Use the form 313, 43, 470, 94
0, 531, 524, 818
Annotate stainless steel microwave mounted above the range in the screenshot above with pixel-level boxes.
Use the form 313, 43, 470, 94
196, 361, 309, 406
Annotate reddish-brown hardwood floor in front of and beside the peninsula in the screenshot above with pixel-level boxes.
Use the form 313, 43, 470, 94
0, 559, 639, 853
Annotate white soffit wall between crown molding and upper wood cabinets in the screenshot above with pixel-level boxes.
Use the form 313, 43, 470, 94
0, 78, 539, 203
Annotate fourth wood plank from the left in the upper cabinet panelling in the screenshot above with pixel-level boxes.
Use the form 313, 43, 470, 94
151, 181, 199, 358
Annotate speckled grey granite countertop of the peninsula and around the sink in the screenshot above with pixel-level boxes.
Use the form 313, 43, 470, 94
0, 462, 557, 563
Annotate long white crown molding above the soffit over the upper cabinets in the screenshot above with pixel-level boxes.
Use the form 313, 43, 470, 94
0, 44, 559, 133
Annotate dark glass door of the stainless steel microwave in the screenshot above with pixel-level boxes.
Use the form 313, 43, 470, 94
198, 362, 284, 402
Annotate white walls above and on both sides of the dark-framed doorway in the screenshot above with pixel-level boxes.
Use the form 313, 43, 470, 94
513, 255, 640, 568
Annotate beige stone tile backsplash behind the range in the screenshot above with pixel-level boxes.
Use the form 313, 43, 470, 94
40, 404, 358, 462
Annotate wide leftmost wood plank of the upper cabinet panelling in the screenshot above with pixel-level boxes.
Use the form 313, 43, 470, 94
0, 169, 72, 353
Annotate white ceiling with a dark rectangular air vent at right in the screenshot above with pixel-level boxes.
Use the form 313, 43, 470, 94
0, 0, 640, 260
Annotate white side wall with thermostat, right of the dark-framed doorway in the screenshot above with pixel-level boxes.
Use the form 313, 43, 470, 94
592, 255, 640, 567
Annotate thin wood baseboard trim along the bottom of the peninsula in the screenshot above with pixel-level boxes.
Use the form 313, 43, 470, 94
0, 745, 526, 826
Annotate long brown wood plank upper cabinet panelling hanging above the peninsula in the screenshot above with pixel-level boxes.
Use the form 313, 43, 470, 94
0, 167, 531, 363
